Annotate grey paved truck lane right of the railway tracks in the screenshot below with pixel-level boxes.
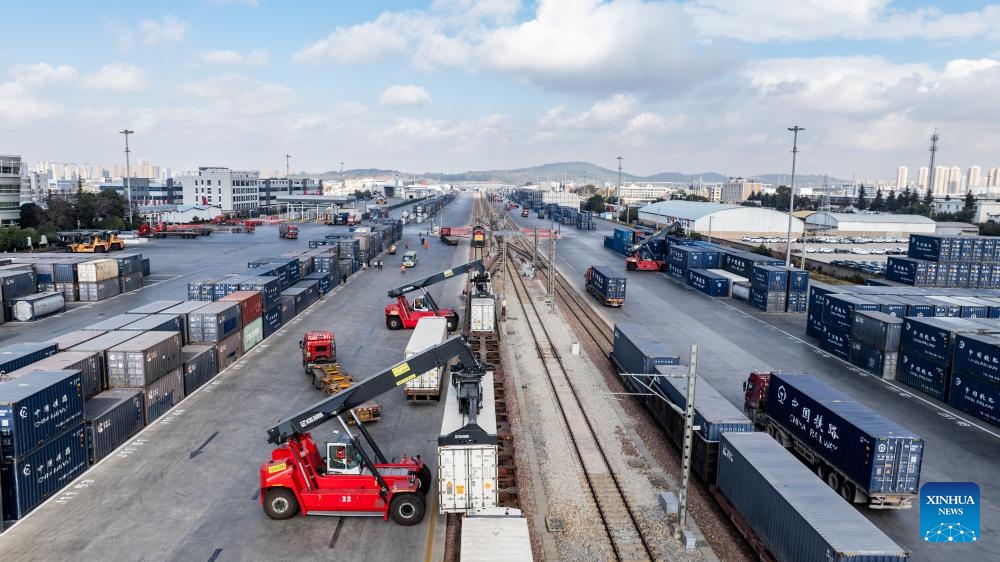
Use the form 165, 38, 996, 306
515, 210, 1000, 562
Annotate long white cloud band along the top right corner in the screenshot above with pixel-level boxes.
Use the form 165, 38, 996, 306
682, 0, 1000, 43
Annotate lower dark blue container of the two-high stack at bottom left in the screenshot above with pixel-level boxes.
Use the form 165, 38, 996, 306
0, 422, 89, 521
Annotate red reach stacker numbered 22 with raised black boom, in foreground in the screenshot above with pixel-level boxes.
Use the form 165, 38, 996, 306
260, 336, 489, 525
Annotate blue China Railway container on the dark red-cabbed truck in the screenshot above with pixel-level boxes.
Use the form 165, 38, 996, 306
767, 373, 924, 496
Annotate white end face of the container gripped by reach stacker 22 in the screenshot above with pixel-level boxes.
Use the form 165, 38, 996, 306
438, 445, 497, 513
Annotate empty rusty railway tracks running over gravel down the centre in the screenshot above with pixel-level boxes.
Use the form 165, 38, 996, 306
475, 195, 657, 560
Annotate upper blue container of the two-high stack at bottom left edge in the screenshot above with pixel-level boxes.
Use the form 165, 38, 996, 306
0, 370, 83, 460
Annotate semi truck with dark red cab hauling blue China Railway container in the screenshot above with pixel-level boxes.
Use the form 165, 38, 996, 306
743, 372, 924, 509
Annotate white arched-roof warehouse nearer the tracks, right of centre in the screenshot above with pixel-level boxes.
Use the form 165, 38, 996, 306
639, 201, 804, 235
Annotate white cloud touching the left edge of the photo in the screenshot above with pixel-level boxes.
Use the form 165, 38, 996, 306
0, 63, 77, 125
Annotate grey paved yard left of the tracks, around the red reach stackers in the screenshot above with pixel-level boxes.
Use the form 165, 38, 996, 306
0, 195, 472, 561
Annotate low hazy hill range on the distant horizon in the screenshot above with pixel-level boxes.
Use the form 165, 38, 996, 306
306, 162, 847, 186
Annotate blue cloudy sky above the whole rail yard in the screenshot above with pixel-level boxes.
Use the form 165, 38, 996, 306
0, 0, 1000, 179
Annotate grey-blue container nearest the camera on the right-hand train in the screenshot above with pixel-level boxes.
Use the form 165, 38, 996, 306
718, 433, 909, 562
